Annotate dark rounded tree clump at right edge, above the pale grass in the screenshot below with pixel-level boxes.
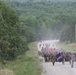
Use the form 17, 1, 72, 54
60, 24, 75, 43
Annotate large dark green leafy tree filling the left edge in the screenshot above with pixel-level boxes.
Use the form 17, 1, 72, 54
0, 1, 27, 60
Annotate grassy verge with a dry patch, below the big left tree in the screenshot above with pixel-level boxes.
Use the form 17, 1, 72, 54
0, 43, 41, 75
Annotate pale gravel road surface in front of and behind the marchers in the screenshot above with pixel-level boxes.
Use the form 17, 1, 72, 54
38, 40, 76, 75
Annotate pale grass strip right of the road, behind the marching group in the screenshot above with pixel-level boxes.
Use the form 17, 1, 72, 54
57, 42, 76, 52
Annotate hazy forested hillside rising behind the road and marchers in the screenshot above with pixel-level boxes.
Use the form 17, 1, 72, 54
6, 1, 76, 42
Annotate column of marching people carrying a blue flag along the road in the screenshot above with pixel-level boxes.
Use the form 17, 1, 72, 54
38, 41, 76, 67
